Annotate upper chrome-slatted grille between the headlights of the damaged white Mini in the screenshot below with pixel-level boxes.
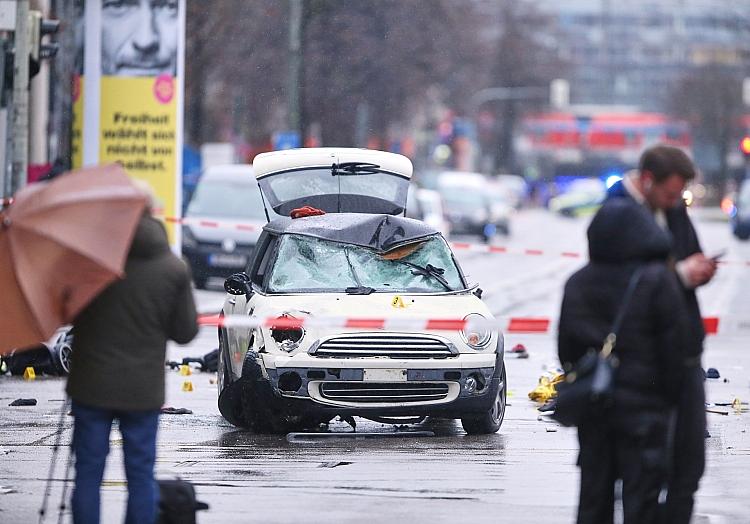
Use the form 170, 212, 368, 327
312, 334, 457, 359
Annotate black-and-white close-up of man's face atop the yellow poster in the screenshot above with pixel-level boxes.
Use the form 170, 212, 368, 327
101, 0, 180, 76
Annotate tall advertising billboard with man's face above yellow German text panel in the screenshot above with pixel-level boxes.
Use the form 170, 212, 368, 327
82, 0, 185, 246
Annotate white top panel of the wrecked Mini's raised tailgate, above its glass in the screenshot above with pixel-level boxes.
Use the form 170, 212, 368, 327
253, 147, 413, 178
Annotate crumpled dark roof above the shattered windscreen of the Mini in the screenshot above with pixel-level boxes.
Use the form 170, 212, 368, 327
263, 213, 439, 252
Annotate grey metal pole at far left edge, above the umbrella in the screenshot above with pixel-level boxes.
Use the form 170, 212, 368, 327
11, 0, 29, 194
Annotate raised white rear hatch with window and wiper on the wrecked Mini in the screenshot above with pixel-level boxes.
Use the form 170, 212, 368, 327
253, 148, 413, 216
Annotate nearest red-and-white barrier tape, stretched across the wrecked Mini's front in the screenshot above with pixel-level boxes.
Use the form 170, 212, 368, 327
199, 315, 750, 335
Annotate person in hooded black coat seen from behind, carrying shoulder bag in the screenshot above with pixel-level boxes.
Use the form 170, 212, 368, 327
558, 200, 687, 524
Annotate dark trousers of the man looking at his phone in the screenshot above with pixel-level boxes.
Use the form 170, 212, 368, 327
667, 367, 706, 524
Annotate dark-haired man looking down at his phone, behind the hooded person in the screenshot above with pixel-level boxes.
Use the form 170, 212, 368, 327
607, 145, 716, 524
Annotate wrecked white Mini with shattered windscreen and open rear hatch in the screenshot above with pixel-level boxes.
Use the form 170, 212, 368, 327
218, 148, 506, 433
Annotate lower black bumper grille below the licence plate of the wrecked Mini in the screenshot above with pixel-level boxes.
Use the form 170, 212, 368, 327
320, 382, 448, 404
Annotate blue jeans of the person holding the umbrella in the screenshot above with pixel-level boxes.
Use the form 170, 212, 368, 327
72, 401, 159, 524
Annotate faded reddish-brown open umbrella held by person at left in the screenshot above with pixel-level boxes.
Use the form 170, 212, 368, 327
0, 164, 147, 354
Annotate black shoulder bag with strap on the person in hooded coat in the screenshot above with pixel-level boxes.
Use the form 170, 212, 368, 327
551, 268, 643, 426
